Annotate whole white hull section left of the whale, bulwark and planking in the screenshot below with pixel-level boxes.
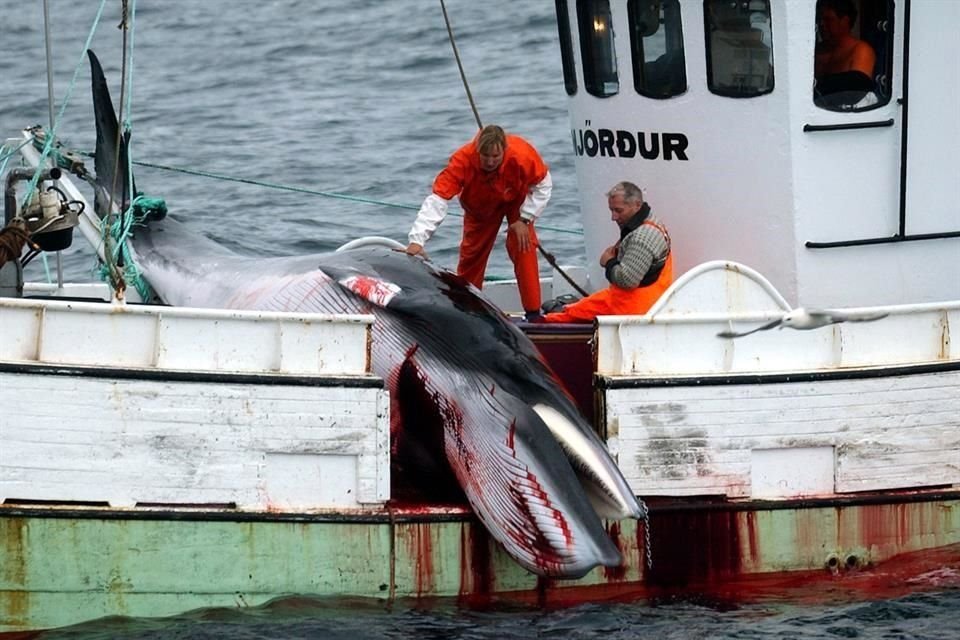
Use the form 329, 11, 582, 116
0, 299, 390, 511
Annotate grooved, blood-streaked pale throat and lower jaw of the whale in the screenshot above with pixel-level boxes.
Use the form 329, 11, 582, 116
434, 382, 622, 578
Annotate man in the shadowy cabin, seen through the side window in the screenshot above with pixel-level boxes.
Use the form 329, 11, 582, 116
814, 0, 877, 102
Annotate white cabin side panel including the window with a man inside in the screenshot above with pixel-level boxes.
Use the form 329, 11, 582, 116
803, 0, 910, 246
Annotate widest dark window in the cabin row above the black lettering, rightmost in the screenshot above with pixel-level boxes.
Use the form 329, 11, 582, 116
703, 0, 773, 98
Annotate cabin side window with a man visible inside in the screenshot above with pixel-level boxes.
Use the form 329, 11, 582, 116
813, 0, 893, 111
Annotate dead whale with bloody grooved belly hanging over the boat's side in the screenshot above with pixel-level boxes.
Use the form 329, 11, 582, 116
91, 51, 645, 577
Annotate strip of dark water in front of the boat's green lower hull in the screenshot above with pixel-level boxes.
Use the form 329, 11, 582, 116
26, 590, 960, 640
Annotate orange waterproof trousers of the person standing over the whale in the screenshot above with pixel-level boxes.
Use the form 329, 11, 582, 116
457, 213, 541, 311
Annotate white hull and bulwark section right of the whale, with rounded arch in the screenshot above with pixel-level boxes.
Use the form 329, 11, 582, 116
597, 263, 960, 499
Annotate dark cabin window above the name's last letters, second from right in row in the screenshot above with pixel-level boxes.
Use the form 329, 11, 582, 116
627, 0, 687, 98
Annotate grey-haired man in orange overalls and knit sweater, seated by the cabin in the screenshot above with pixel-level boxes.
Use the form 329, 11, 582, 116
543, 182, 673, 323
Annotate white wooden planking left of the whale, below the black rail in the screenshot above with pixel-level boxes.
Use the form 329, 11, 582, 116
0, 373, 389, 509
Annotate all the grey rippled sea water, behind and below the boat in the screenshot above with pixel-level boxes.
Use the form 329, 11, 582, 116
0, 0, 960, 640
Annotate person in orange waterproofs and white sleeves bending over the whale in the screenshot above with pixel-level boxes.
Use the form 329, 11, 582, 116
406, 125, 553, 320
